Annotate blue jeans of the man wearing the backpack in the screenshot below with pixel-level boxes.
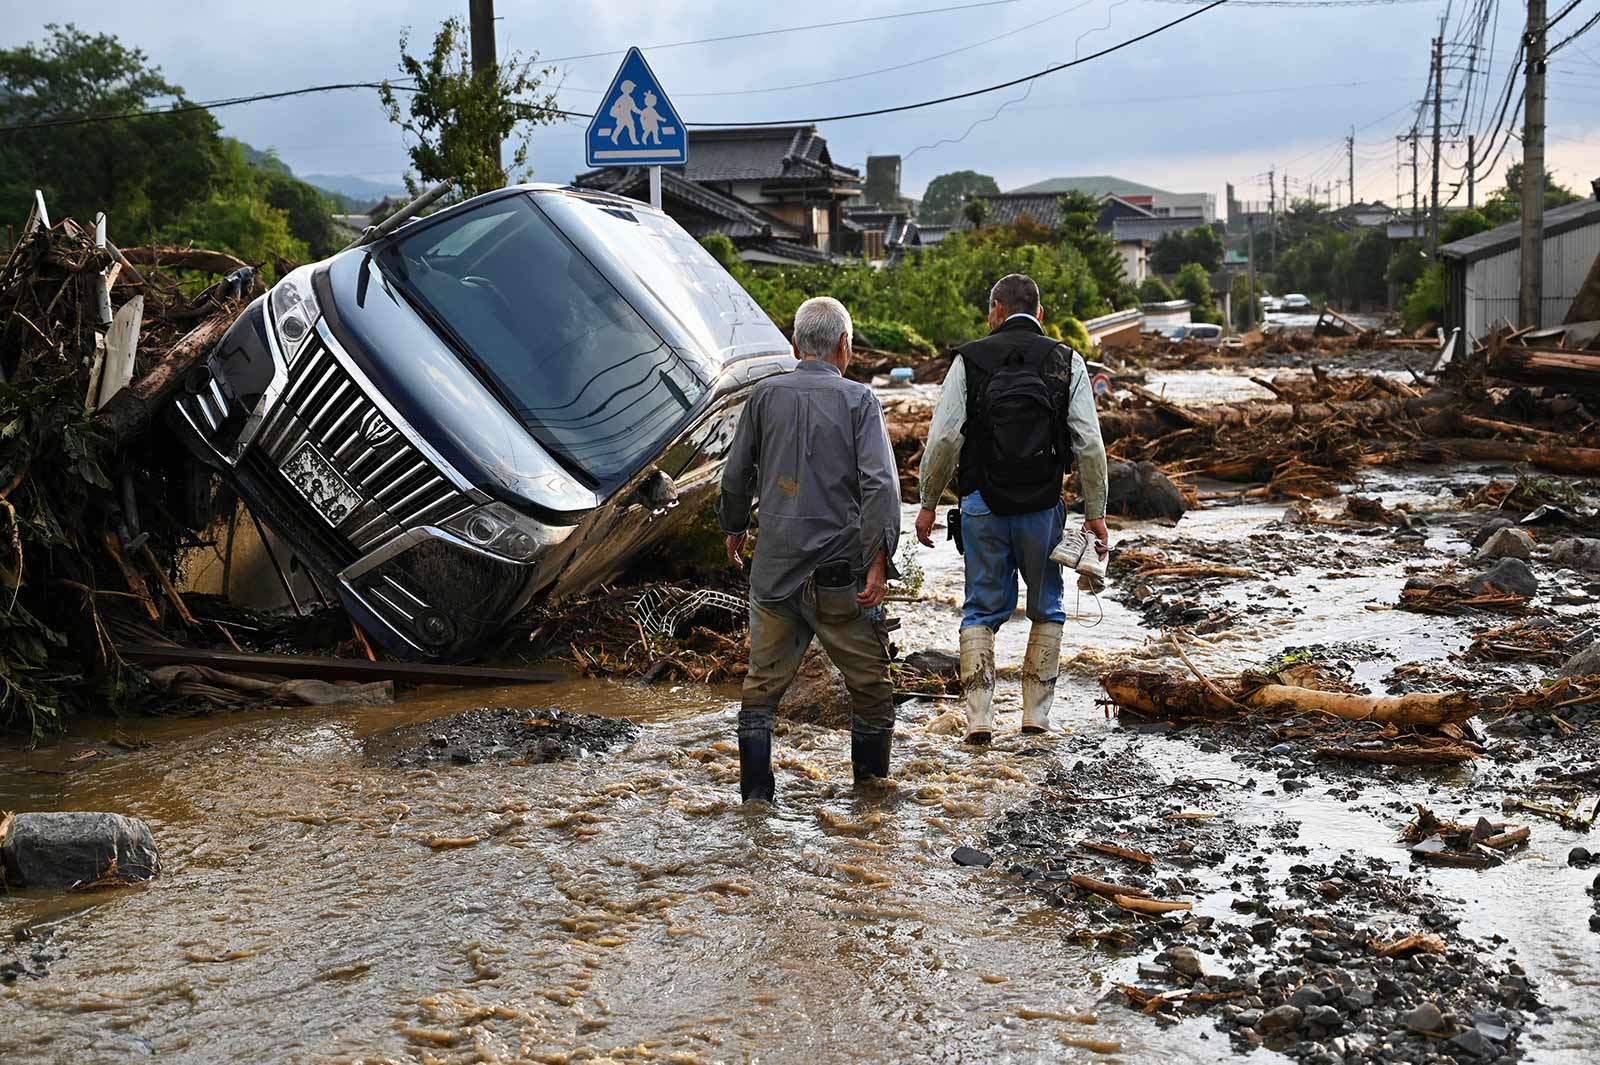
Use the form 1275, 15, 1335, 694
962, 493, 1067, 628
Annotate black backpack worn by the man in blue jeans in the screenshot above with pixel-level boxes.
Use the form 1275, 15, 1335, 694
976, 342, 1067, 515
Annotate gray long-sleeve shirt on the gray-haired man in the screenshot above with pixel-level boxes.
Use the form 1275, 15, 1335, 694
717, 358, 899, 603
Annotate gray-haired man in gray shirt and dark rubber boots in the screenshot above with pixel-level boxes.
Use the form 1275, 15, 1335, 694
717, 296, 899, 803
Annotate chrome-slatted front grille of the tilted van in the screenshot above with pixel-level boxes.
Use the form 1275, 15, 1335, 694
253, 334, 472, 555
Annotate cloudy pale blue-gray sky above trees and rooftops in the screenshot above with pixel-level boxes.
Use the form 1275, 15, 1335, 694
0, 0, 1600, 209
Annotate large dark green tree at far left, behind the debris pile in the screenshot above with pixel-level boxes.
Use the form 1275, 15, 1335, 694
0, 24, 219, 245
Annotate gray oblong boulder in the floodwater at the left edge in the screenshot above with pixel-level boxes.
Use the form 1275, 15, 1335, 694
0, 812, 162, 891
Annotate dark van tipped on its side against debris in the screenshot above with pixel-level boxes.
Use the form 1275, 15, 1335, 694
176, 185, 794, 659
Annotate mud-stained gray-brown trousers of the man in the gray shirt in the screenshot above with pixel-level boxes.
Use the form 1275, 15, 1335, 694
739, 587, 894, 734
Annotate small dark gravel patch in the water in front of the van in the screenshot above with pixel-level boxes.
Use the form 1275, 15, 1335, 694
365, 707, 638, 768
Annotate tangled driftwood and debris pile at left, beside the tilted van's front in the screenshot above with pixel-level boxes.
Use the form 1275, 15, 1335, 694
0, 201, 259, 734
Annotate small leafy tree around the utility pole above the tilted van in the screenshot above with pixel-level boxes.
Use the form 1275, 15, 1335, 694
378, 18, 558, 197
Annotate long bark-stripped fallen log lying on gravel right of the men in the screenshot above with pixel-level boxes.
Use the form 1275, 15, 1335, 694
1101, 670, 1478, 726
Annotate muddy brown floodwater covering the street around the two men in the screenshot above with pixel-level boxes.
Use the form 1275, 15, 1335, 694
0, 364, 1600, 1065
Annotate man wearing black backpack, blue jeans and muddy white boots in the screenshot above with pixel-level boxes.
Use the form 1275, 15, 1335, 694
917, 273, 1109, 744
